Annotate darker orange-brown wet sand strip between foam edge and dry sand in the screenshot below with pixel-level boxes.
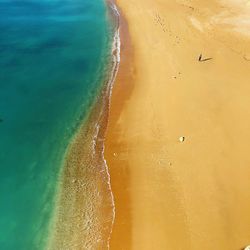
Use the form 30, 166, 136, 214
104, 1, 135, 249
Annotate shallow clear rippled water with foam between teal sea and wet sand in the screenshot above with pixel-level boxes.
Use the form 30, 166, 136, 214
48, 2, 120, 249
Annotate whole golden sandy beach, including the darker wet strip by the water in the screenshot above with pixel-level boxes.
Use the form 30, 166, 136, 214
105, 0, 250, 250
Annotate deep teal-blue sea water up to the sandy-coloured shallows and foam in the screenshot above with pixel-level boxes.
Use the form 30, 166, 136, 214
0, 0, 111, 250
